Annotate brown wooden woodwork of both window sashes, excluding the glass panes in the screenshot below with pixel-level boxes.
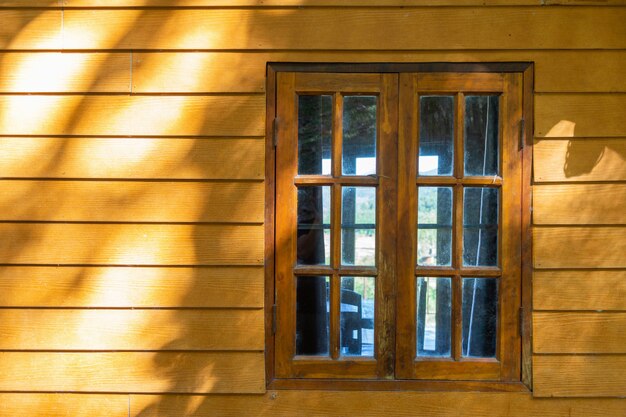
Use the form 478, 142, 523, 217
274, 72, 521, 381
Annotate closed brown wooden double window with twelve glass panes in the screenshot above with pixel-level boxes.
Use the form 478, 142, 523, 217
268, 64, 527, 382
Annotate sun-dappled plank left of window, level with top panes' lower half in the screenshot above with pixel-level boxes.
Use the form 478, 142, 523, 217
0, 137, 264, 180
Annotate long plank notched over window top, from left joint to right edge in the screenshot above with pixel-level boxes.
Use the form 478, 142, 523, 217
133, 50, 626, 93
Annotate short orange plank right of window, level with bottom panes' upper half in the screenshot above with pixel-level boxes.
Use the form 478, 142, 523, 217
533, 270, 626, 310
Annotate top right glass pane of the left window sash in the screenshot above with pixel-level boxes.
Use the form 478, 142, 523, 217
342, 96, 378, 175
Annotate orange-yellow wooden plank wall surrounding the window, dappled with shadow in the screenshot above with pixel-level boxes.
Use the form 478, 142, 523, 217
0, 0, 626, 416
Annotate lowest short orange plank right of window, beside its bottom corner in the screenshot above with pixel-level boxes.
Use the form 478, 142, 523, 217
533, 355, 626, 396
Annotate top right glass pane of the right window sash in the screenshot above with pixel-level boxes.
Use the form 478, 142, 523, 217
464, 96, 499, 175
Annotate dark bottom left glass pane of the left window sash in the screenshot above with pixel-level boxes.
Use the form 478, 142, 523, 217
296, 277, 330, 355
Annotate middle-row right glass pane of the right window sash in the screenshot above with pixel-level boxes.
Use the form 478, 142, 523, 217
463, 187, 500, 266
